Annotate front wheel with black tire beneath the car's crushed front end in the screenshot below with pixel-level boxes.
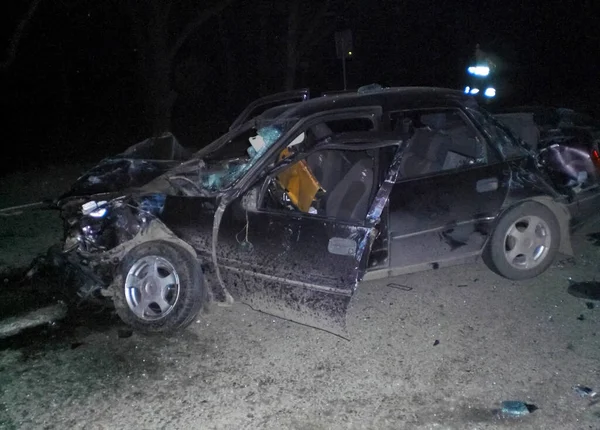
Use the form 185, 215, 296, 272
113, 241, 207, 333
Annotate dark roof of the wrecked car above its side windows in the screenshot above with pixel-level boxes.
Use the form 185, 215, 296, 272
274, 87, 477, 121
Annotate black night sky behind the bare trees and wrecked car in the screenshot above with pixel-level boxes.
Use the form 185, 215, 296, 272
0, 0, 600, 172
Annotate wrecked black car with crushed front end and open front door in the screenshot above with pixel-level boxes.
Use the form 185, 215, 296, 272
52, 88, 600, 332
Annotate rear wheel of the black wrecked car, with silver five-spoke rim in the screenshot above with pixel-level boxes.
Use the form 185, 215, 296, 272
487, 202, 560, 280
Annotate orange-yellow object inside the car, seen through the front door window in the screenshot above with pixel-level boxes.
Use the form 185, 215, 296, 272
277, 148, 321, 212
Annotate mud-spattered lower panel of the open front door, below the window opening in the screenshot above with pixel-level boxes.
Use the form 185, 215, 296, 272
212, 144, 399, 334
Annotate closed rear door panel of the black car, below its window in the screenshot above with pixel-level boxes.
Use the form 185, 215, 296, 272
389, 163, 510, 269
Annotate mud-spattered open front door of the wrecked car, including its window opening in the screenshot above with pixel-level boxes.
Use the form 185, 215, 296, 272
212, 122, 400, 336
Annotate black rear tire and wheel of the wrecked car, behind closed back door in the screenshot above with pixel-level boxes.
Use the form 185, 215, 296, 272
484, 201, 560, 280
